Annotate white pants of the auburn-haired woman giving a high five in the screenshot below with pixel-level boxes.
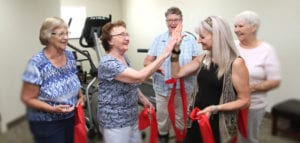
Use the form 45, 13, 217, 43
100, 124, 142, 143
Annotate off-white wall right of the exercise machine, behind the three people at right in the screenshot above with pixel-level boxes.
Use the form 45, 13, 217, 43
123, 0, 300, 111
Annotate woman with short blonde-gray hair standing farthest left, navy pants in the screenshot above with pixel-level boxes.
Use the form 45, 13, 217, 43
21, 17, 84, 143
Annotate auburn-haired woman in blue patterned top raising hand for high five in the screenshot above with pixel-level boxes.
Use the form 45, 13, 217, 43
97, 21, 178, 143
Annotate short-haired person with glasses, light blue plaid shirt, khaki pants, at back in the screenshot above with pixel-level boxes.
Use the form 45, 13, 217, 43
144, 7, 200, 143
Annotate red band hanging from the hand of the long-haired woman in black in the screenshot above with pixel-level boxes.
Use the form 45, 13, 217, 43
190, 107, 215, 143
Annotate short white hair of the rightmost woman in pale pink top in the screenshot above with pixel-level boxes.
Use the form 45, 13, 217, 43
235, 10, 260, 34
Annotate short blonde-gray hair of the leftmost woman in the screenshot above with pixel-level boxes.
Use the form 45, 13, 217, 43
39, 17, 68, 45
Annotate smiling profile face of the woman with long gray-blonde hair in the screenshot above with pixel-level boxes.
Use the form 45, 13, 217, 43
198, 29, 212, 51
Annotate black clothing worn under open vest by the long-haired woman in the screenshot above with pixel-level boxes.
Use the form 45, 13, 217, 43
184, 63, 224, 143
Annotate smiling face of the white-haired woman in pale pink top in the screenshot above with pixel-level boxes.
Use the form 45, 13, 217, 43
234, 20, 256, 41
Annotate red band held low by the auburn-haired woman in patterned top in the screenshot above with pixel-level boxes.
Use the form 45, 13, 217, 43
139, 108, 158, 143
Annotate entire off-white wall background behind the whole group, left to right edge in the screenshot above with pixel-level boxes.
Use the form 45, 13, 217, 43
0, 0, 300, 131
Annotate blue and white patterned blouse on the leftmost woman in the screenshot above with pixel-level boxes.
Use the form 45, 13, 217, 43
22, 50, 81, 121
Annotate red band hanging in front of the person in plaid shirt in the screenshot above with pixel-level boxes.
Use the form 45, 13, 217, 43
166, 78, 187, 141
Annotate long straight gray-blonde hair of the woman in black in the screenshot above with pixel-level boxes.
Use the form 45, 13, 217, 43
196, 16, 239, 78
